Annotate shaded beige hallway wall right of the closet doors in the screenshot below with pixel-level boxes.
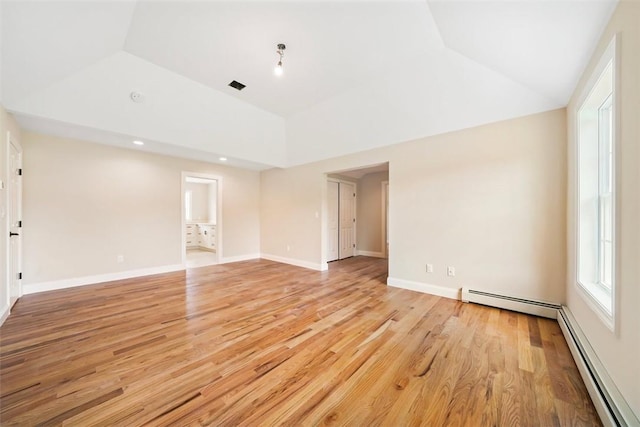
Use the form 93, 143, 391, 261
356, 172, 389, 255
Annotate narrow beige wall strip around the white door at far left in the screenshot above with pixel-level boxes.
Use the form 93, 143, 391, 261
0, 105, 21, 317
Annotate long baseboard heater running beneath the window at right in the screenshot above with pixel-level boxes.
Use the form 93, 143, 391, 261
558, 306, 640, 426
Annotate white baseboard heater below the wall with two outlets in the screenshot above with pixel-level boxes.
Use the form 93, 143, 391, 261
462, 288, 561, 319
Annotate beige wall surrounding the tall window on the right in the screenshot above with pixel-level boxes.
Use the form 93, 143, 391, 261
567, 1, 640, 417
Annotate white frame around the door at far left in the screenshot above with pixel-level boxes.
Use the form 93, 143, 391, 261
5, 131, 23, 311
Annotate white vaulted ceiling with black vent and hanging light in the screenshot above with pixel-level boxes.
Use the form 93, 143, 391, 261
0, 0, 616, 169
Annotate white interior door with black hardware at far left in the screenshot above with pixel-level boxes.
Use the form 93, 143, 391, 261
7, 135, 22, 306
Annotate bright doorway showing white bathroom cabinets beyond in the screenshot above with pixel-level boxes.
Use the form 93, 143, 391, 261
182, 172, 222, 268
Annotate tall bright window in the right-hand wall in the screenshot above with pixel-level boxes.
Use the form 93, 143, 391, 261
576, 39, 616, 327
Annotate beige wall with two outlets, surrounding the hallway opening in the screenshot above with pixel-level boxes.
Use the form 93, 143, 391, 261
261, 109, 566, 302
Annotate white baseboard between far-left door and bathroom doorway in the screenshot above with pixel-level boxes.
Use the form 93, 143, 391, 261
22, 264, 185, 295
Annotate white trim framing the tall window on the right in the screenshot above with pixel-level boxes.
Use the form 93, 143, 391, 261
574, 35, 621, 333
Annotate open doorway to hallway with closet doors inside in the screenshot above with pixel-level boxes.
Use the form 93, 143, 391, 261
325, 163, 389, 262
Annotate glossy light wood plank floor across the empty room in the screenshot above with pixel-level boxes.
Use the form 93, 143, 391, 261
0, 257, 599, 426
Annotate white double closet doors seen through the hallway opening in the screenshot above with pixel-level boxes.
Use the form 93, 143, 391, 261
327, 180, 356, 261
